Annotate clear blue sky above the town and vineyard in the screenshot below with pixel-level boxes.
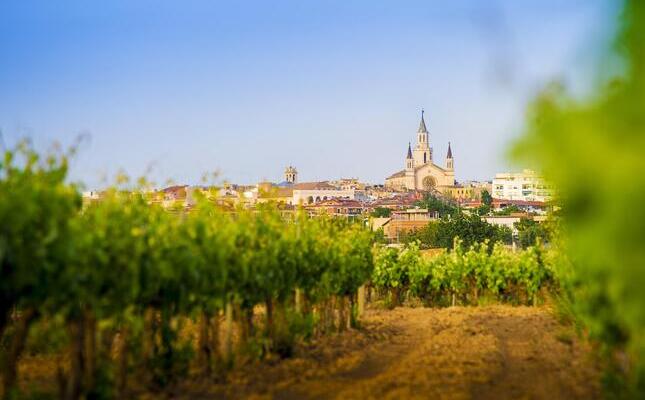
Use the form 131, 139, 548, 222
0, 0, 616, 188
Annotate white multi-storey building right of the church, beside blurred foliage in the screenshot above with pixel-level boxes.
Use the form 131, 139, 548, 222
492, 169, 553, 202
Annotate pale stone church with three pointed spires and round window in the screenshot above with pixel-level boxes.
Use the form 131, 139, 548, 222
385, 110, 455, 192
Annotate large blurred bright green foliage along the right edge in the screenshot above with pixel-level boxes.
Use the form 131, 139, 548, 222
513, 0, 645, 398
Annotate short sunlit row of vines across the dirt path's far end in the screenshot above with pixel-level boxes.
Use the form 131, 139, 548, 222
371, 239, 557, 306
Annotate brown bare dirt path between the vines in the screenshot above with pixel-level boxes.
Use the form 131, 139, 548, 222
180, 306, 600, 399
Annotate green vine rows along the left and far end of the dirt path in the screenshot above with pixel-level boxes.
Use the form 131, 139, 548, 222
0, 148, 553, 399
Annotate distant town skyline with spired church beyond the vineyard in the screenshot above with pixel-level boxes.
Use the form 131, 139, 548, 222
84, 111, 553, 238
